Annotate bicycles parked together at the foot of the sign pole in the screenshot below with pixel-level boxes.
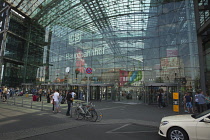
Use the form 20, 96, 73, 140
74, 102, 102, 122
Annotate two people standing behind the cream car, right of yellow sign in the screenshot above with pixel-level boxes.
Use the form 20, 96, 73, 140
183, 91, 210, 113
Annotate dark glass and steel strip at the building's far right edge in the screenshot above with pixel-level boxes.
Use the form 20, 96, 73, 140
195, 0, 210, 95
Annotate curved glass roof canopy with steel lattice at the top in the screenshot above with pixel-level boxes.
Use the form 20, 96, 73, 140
4, 0, 162, 70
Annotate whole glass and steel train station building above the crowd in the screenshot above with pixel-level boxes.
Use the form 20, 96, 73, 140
0, 0, 210, 103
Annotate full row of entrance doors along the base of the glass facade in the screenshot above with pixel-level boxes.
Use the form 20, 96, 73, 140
22, 83, 178, 105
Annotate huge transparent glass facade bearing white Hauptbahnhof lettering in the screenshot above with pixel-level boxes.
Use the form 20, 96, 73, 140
0, 0, 200, 102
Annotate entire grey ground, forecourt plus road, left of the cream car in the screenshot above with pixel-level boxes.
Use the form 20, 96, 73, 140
0, 96, 182, 140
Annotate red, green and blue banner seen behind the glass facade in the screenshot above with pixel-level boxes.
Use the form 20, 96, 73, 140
119, 70, 142, 86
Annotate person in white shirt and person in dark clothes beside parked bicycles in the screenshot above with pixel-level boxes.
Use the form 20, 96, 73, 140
49, 90, 76, 116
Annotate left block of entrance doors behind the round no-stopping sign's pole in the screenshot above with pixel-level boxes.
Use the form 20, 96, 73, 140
22, 83, 116, 101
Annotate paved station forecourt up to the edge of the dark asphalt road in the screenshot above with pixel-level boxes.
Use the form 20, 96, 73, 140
0, 97, 185, 140
